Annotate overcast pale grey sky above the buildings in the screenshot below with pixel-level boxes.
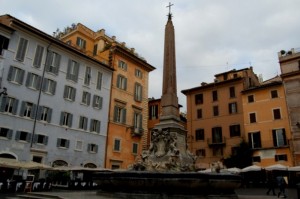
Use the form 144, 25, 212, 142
0, 0, 300, 111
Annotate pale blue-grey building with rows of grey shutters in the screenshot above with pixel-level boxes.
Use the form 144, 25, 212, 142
0, 15, 113, 171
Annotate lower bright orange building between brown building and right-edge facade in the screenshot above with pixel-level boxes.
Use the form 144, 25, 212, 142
242, 76, 293, 167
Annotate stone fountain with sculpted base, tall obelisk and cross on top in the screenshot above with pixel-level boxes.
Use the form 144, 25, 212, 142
94, 4, 241, 198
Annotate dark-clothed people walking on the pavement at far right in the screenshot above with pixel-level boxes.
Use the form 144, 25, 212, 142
267, 172, 288, 198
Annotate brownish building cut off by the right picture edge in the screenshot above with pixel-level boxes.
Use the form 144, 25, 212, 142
278, 49, 300, 166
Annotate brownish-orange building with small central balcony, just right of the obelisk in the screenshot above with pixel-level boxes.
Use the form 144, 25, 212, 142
182, 67, 259, 165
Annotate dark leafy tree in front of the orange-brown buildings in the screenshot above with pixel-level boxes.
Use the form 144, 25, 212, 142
223, 140, 253, 168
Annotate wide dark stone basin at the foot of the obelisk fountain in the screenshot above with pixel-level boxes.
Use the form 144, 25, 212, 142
93, 171, 241, 195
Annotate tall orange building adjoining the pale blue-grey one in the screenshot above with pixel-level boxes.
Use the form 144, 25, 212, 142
57, 23, 155, 169
